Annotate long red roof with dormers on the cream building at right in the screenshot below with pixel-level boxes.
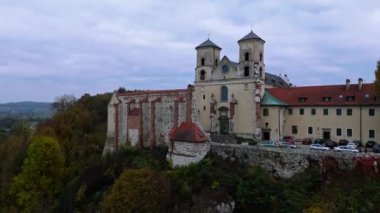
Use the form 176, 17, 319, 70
267, 84, 380, 106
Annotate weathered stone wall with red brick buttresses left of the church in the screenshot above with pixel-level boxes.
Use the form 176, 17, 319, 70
104, 87, 200, 152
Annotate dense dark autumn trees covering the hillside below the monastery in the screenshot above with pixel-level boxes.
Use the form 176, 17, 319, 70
0, 94, 380, 212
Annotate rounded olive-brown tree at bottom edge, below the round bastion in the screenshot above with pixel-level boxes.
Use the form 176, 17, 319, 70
102, 168, 170, 213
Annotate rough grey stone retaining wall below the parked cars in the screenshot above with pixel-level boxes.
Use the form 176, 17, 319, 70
211, 143, 370, 178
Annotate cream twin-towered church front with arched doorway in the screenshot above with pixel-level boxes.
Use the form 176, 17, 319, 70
194, 32, 265, 138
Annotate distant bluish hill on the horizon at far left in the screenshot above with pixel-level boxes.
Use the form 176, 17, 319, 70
0, 101, 54, 118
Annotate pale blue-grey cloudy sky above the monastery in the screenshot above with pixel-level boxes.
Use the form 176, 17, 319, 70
0, 0, 380, 103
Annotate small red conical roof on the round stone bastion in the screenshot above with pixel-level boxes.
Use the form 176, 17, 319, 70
169, 122, 208, 143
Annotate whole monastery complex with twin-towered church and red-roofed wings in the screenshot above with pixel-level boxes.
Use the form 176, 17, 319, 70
101, 31, 380, 161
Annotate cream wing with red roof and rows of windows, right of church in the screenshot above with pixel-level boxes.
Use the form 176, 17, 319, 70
261, 79, 380, 143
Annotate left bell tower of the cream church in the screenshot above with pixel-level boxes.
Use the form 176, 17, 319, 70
195, 39, 222, 82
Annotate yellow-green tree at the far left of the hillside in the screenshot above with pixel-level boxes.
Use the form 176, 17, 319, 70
11, 137, 64, 212
